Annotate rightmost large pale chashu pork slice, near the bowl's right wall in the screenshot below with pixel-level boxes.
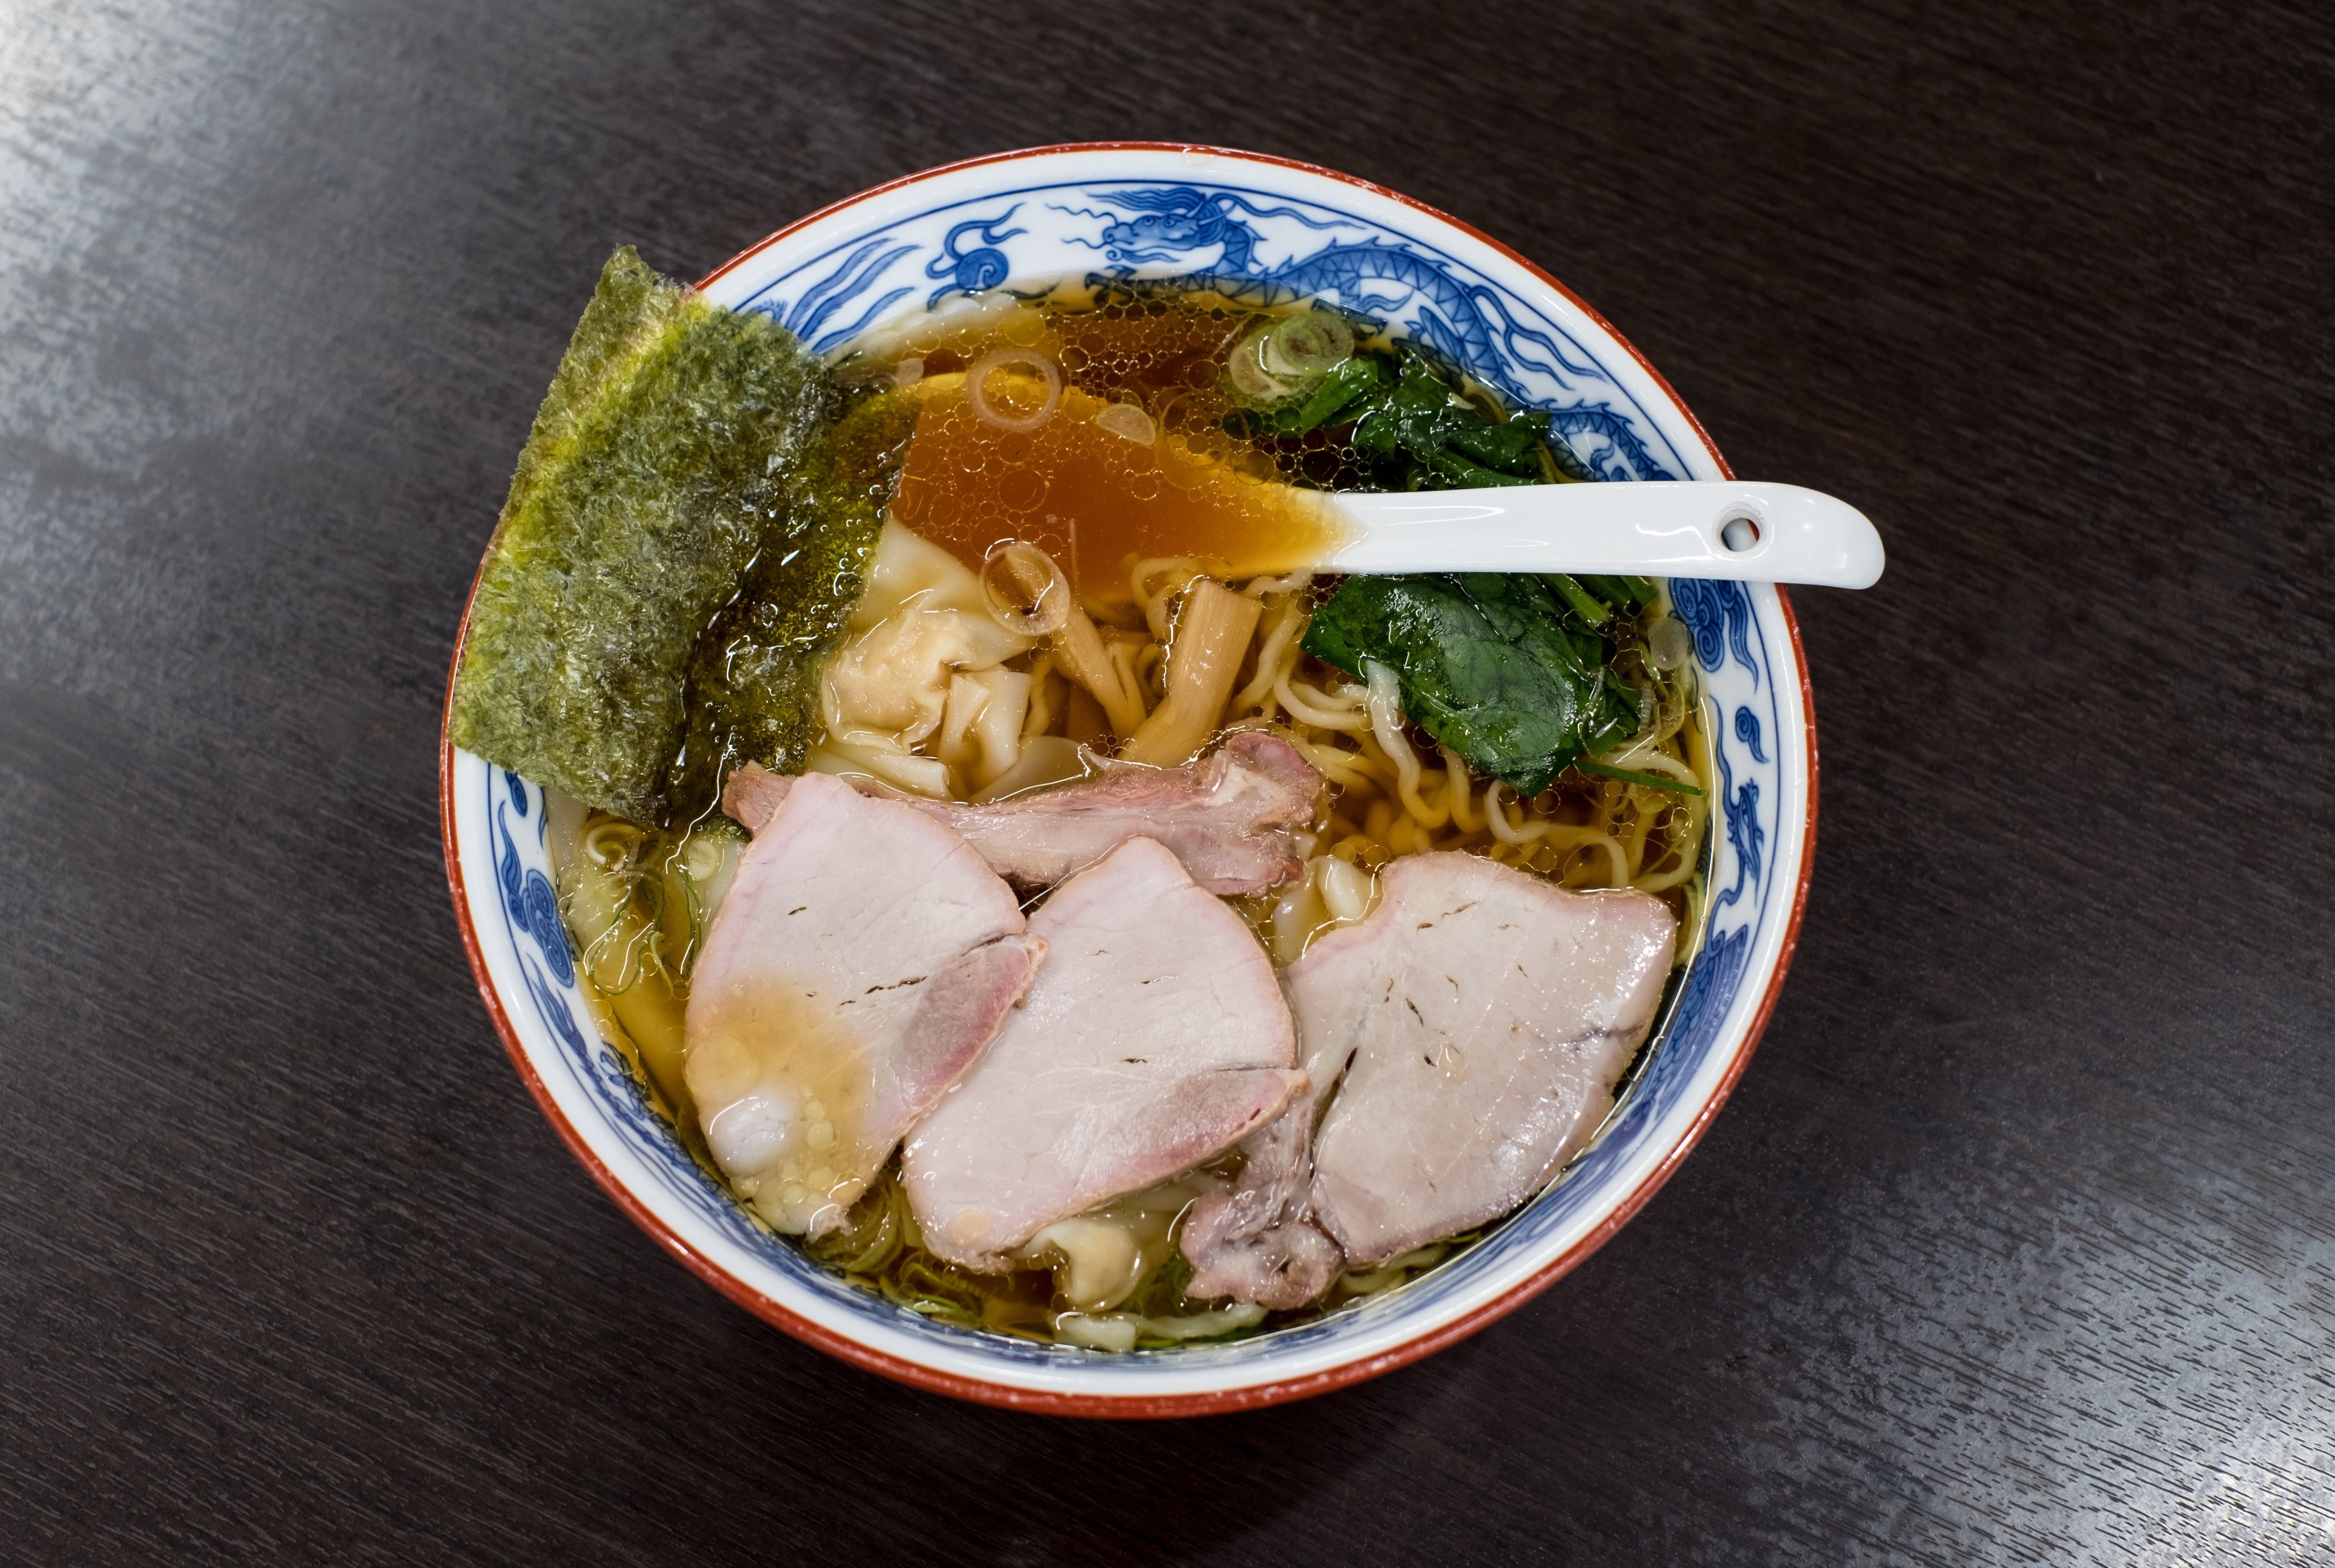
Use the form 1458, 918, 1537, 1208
1282, 852, 1676, 1267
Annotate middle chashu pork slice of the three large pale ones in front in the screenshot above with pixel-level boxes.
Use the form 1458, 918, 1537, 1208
901, 838, 1305, 1272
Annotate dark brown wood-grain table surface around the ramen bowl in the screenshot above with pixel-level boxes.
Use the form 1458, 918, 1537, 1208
0, 0, 2335, 1568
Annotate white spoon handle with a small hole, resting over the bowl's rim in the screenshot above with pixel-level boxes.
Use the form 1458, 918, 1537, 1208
1324, 478, 1885, 588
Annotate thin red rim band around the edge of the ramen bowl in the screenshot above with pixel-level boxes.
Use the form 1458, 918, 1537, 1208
439, 143, 1817, 1419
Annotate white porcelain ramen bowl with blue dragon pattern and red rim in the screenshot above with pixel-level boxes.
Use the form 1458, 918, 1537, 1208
441, 143, 1817, 1416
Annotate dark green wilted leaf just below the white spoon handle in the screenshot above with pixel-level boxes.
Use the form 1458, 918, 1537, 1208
1303, 572, 1639, 795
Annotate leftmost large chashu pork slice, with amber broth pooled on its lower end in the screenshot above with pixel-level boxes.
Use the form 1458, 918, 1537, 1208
687, 775, 1046, 1234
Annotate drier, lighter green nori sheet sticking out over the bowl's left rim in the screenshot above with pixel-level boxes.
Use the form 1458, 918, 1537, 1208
448, 247, 854, 821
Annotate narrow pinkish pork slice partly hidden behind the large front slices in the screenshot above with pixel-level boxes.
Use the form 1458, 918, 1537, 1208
721, 730, 1322, 893
